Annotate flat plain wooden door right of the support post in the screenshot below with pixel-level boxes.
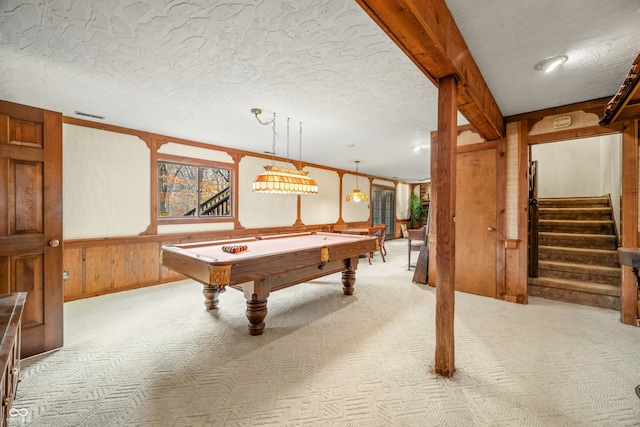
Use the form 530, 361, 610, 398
455, 148, 498, 298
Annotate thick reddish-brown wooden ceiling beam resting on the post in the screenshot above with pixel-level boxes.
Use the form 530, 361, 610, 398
356, 0, 504, 141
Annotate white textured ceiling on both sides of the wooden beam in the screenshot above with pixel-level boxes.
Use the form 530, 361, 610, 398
0, 0, 640, 182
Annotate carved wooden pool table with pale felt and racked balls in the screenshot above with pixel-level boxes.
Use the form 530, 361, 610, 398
160, 232, 377, 335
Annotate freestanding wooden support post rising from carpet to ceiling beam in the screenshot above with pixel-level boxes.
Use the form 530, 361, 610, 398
435, 75, 458, 377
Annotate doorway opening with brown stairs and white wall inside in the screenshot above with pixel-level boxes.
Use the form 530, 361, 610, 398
527, 134, 622, 310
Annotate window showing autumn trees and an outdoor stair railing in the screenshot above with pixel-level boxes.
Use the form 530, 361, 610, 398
158, 161, 231, 219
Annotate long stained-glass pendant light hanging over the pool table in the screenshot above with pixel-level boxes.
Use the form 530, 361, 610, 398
251, 108, 318, 194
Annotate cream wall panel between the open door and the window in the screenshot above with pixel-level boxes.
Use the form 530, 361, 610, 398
62, 124, 151, 240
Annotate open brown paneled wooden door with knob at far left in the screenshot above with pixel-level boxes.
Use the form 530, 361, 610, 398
0, 101, 64, 357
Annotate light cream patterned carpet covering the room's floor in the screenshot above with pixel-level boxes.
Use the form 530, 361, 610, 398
10, 239, 640, 427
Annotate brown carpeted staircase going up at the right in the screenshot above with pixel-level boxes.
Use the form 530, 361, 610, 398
529, 196, 621, 310
